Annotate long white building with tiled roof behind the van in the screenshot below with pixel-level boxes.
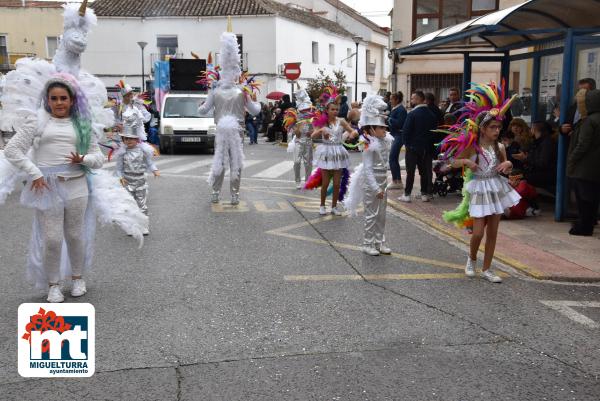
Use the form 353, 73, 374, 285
83, 0, 375, 98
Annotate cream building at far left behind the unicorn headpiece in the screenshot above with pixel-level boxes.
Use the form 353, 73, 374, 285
0, 0, 63, 73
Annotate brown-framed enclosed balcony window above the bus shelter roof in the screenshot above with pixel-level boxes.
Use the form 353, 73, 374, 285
413, 0, 499, 38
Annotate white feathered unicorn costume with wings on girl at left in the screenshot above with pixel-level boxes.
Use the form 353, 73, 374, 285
0, 4, 148, 288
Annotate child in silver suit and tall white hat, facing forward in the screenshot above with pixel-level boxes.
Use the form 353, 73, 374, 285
344, 95, 394, 256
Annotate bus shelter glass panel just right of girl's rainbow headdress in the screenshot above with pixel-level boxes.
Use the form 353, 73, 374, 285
508, 59, 533, 124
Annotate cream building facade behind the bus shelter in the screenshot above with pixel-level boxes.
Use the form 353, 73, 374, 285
391, 0, 526, 104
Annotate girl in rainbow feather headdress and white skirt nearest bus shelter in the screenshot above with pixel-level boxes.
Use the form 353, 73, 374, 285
441, 82, 521, 283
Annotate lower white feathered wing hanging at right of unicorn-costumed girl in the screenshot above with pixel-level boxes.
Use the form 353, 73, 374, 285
91, 170, 148, 248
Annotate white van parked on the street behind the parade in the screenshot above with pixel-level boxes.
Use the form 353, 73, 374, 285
159, 93, 216, 154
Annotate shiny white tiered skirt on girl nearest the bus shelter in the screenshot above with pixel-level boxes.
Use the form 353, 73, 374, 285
467, 175, 521, 217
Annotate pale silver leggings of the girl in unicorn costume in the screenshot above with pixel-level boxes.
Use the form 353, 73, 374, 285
36, 196, 88, 284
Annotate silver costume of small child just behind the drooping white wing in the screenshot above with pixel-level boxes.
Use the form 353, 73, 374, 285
117, 144, 158, 215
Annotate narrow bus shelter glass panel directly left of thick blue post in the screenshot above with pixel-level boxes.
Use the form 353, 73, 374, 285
536, 54, 563, 120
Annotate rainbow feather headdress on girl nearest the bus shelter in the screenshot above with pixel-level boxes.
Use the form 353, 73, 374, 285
436, 81, 517, 159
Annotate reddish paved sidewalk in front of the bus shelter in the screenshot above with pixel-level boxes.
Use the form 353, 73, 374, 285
388, 181, 600, 282
